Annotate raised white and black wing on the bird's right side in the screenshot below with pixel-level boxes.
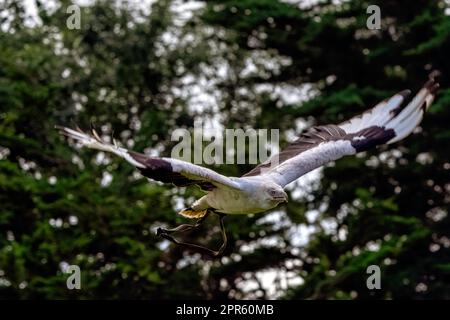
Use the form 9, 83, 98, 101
244, 73, 439, 187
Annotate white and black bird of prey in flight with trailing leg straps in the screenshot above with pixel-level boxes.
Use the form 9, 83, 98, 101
57, 72, 439, 256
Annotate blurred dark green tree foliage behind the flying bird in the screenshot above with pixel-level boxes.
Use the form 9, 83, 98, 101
0, 0, 450, 299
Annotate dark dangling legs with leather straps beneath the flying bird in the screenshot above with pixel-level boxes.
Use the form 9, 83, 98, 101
156, 211, 227, 257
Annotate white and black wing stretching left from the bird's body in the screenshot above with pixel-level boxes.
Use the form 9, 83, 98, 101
57, 126, 241, 191
